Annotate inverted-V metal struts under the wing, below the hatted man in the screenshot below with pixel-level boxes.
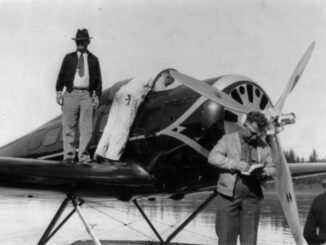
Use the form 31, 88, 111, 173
37, 194, 101, 245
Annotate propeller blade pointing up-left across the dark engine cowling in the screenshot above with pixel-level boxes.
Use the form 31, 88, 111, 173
170, 71, 250, 114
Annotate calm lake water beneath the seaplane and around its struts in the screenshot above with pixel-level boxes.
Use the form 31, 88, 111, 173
0, 193, 318, 245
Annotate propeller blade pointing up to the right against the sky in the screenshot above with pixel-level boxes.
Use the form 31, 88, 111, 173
273, 41, 315, 116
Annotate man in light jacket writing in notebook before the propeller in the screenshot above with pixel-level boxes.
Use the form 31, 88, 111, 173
208, 112, 276, 245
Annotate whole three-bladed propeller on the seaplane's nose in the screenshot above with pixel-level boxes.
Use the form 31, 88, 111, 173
170, 42, 315, 245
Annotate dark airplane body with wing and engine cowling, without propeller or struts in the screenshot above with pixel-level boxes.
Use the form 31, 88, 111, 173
0, 75, 270, 200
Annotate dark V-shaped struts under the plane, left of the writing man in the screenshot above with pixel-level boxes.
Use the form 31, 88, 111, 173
133, 191, 217, 244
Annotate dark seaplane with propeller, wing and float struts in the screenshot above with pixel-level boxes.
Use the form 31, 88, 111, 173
0, 42, 326, 245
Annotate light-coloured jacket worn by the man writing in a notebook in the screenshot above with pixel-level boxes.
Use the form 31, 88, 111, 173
208, 132, 276, 197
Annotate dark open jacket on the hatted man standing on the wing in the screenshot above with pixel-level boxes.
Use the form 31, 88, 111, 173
56, 51, 102, 97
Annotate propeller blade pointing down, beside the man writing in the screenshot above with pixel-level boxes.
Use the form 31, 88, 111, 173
271, 135, 305, 245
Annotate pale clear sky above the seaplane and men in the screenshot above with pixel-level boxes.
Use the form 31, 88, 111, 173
0, 0, 326, 158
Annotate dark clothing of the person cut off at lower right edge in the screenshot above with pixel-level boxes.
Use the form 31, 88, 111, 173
303, 192, 326, 245
